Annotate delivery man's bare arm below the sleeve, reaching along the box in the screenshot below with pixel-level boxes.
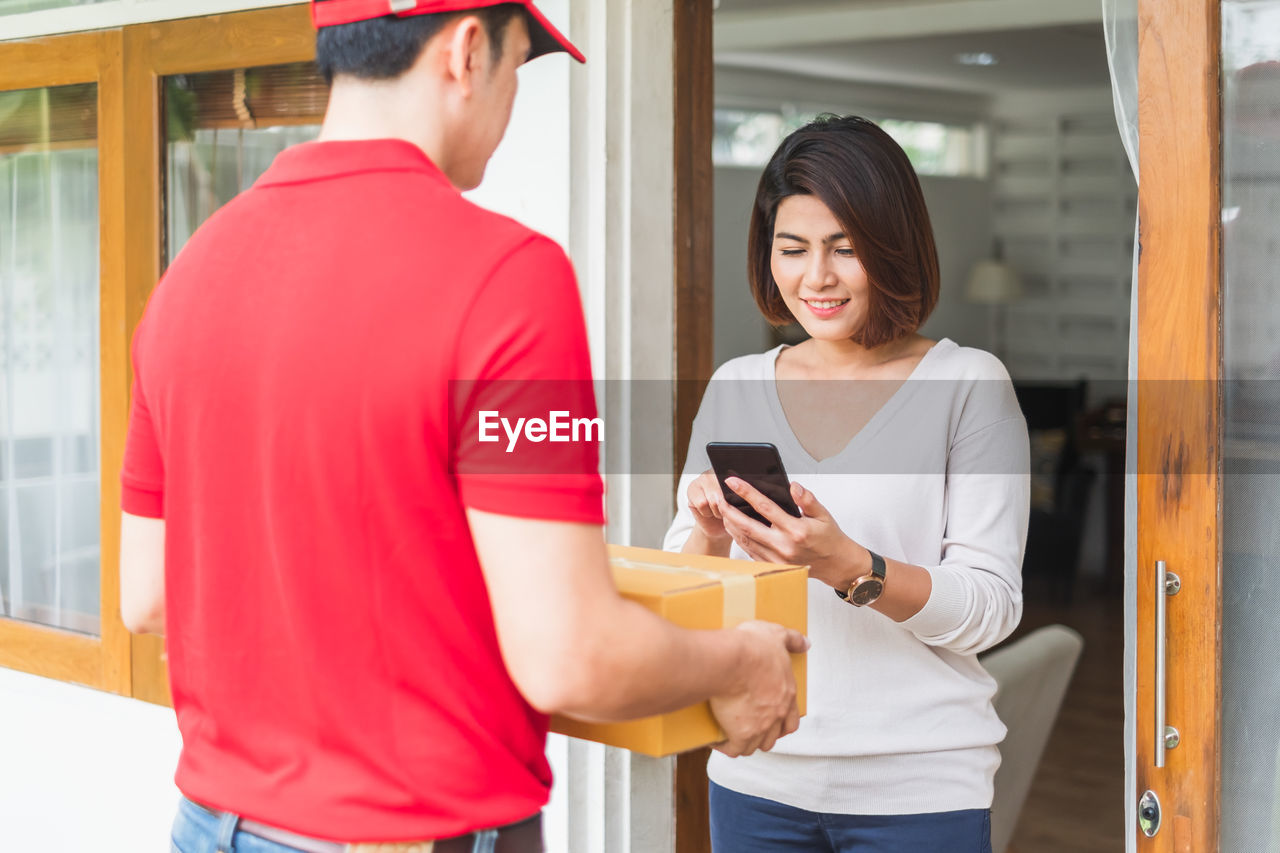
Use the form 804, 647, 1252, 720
467, 508, 773, 721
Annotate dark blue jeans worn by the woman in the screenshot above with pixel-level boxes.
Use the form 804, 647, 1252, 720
710, 783, 991, 853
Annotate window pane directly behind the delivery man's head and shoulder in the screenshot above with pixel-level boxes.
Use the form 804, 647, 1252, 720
165, 63, 329, 261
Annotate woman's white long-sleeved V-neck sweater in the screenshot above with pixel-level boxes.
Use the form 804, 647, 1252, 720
663, 338, 1030, 815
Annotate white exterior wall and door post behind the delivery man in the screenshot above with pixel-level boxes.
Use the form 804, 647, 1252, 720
0, 0, 675, 853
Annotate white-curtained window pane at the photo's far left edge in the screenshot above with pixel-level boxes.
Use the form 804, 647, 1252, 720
0, 83, 100, 634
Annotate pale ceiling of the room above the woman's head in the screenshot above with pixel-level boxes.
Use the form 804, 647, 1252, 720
716, 0, 1110, 93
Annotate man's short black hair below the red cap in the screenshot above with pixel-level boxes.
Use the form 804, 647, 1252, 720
316, 3, 525, 83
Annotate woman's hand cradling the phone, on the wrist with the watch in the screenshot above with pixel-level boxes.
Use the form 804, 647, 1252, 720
721, 476, 870, 589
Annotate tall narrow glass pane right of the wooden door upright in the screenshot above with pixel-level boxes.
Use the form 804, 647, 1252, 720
1220, 0, 1280, 853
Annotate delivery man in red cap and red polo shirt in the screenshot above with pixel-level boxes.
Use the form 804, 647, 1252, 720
120, 0, 806, 853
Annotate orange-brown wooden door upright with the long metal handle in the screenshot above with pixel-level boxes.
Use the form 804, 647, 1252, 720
1126, 0, 1222, 853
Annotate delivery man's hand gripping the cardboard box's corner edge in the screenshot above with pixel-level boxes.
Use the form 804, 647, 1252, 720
710, 621, 809, 757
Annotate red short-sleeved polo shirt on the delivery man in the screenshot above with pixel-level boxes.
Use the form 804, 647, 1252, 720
123, 140, 603, 841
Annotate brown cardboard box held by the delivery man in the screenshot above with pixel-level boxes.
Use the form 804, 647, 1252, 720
552, 546, 809, 756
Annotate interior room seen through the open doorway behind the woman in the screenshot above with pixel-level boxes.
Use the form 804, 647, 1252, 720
713, 0, 1138, 853
